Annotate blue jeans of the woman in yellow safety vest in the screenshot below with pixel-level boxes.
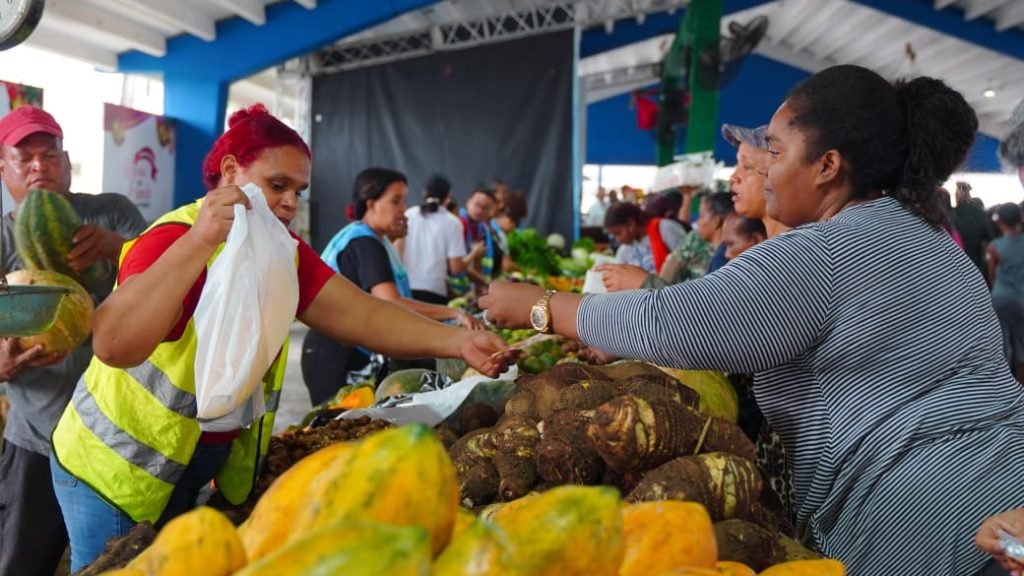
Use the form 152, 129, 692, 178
50, 442, 231, 574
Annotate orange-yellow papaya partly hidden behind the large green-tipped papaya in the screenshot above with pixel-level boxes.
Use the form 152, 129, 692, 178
239, 443, 354, 562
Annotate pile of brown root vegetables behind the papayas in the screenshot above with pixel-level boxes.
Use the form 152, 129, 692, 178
450, 362, 806, 570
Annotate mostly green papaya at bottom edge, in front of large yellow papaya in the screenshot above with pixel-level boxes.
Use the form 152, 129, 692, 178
234, 521, 430, 576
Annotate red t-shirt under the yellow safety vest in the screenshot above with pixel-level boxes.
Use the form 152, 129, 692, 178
118, 223, 335, 341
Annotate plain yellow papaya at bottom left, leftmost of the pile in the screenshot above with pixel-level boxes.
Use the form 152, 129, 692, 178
128, 506, 246, 576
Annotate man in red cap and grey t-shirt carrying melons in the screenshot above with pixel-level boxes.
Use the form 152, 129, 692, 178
0, 106, 145, 576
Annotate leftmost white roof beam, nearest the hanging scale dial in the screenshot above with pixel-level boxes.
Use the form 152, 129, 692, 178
45, 0, 167, 57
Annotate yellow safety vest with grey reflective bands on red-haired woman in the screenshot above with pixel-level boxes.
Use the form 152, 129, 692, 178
53, 200, 298, 522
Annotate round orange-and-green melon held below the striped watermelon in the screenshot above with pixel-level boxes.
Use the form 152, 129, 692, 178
7, 270, 93, 354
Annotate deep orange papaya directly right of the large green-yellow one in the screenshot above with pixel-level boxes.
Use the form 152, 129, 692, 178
618, 500, 718, 576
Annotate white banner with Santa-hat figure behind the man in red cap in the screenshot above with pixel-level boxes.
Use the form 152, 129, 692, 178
103, 104, 175, 221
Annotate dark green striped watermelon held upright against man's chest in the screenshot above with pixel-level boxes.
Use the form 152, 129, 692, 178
14, 189, 106, 292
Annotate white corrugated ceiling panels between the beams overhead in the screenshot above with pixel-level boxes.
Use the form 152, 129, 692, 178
8, 0, 1024, 136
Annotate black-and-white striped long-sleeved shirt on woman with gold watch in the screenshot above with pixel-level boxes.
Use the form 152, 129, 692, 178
577, 198, 1024, 576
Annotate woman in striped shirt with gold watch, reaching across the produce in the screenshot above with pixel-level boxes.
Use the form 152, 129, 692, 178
481, 66, 1024, 576
